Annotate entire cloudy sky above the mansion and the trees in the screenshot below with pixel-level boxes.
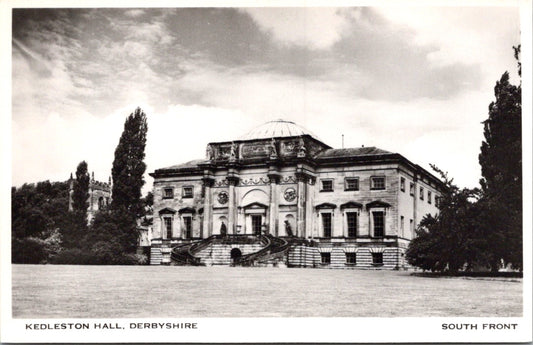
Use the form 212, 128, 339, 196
11, 2, 520, 192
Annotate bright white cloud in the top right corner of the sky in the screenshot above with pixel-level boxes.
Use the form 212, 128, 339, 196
377, 6, 520, 80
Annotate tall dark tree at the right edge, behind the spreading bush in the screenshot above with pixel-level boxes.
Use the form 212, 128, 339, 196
479, 46, 522, 269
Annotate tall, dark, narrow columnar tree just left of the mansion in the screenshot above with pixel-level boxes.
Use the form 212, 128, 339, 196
111, 108, 148, 252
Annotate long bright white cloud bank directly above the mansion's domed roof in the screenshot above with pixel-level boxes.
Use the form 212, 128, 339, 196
172, 58, 492, 186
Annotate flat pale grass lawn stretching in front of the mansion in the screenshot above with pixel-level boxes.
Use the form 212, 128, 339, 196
12, 265, 522, 318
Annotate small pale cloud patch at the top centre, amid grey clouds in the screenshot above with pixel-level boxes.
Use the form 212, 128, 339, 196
244, 7, 347, 49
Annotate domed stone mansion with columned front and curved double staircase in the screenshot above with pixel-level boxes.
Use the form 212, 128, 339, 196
150, 120, 443, 269
